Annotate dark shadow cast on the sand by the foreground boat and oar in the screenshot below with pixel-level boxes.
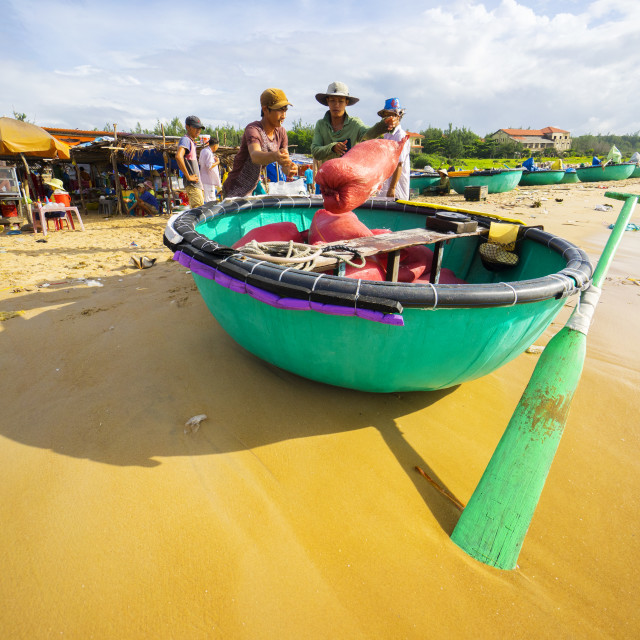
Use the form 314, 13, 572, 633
0, 263, 468, 533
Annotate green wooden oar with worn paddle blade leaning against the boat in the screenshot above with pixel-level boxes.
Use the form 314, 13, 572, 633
451, 192, 639, 569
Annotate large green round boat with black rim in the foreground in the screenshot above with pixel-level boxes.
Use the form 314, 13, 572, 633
164, 196, 592, 392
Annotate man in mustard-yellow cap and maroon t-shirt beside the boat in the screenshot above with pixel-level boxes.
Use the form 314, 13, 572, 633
222, 89, 297, 198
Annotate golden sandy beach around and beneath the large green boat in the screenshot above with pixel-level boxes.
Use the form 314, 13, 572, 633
0, 179, 640, 640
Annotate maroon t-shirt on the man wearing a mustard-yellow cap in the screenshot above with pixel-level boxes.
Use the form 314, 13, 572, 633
222, 120, 289, 198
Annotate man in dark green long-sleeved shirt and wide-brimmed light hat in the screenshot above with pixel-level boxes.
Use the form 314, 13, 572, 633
311, 82, 400, 162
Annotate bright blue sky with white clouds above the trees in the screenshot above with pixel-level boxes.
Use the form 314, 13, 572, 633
0, 0, 640, 136
